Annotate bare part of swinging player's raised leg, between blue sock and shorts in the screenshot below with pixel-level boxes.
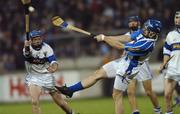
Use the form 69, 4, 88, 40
81, 68, 107, 88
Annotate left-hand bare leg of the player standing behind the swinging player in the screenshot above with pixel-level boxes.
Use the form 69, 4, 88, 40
127, 80, 138, 112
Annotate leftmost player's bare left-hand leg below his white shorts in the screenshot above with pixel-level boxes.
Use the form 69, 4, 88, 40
29, 85, 41, 114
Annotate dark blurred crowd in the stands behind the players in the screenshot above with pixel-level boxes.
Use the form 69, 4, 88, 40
0, 0, 180, 73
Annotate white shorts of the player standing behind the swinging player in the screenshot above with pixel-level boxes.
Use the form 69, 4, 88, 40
134, 61, 153, 82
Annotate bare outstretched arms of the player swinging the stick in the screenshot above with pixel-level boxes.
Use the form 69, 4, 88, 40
95, 34, 131, 49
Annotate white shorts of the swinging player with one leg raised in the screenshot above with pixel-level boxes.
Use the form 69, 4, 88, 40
103, 57, 141, 91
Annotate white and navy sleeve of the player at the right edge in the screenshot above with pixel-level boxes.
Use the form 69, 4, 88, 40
163, 33, 172, 56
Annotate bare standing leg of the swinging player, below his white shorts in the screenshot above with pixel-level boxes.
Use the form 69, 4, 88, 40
113, 89, 124, 114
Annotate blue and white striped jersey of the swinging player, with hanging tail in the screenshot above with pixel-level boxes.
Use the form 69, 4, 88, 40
122, 29, 156, 75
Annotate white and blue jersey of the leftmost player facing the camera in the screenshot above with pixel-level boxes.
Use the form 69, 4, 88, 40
23, 43, 56, 74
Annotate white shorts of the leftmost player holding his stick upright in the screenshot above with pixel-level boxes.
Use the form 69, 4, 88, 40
25, 74, 55, 92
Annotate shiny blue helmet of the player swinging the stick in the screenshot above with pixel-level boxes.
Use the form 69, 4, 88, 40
144, 19, 162, 33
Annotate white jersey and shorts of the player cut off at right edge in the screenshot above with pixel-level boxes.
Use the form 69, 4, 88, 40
163, 30, 180, 75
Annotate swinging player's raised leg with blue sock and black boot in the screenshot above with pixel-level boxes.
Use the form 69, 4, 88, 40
56, 59, 121, 97
